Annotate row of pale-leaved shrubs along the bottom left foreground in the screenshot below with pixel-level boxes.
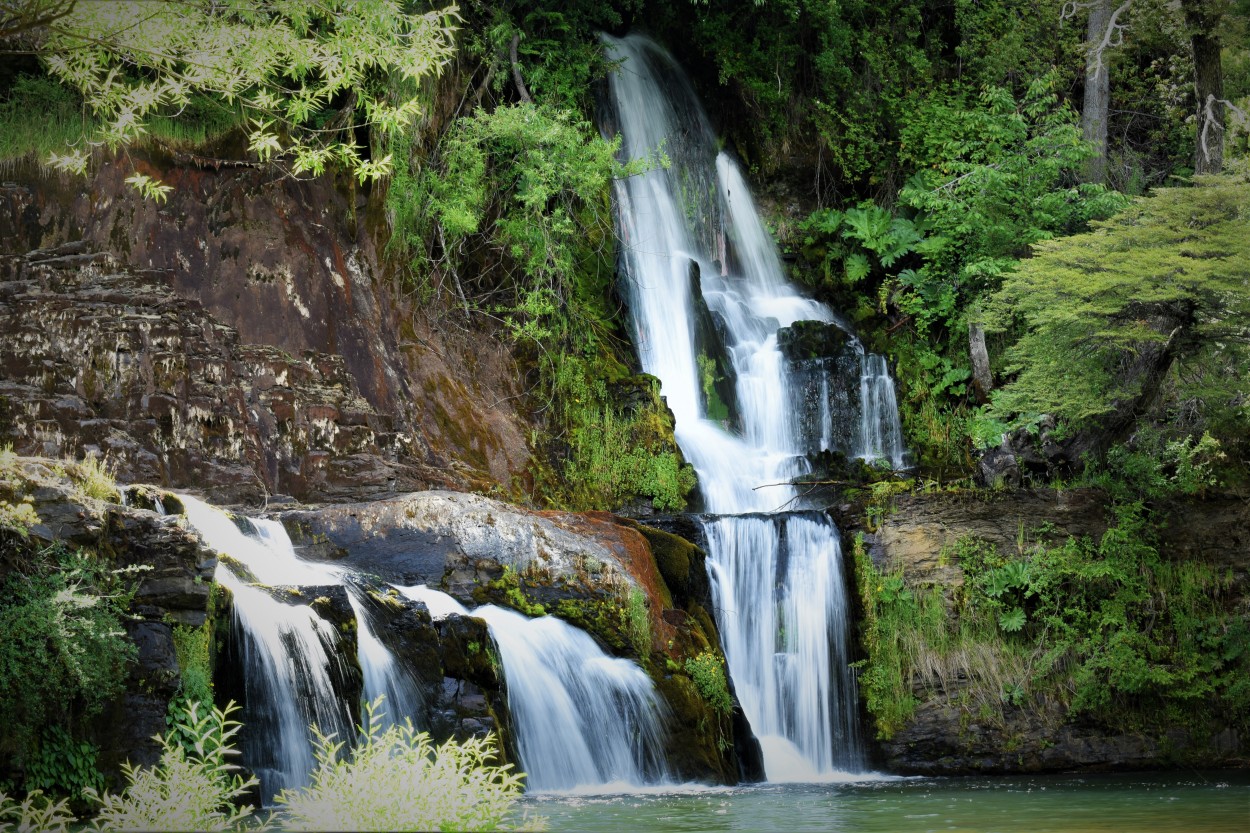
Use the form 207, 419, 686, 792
0, 698, 532, 833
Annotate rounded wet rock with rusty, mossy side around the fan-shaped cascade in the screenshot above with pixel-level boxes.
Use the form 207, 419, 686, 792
278, 492, 740, 783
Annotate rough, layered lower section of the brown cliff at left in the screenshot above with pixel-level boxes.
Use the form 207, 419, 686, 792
0, 246, 450, 503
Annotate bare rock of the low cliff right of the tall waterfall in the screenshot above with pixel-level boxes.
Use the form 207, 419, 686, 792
865, 489, 1250, 774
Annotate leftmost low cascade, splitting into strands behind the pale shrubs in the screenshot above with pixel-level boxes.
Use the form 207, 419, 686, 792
180, 495, 420, 800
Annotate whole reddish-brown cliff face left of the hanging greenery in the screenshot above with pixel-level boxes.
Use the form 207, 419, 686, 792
0, 151, 529, 503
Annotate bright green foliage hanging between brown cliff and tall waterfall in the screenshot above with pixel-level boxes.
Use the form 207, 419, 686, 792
386, 98, 695, 510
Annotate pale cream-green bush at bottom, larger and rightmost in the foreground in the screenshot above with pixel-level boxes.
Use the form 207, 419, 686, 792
276, 698, 541, 830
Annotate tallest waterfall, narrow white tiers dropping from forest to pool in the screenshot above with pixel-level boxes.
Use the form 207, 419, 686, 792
604, 35, 904, 780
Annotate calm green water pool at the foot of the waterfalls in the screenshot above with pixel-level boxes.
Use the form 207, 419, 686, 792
525, 770, 1250, 833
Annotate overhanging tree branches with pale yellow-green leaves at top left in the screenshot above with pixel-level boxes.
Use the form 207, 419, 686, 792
3, 0, 458, 192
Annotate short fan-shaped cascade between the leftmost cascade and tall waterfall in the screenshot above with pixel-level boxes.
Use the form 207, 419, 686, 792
398, 585, 666, 792
